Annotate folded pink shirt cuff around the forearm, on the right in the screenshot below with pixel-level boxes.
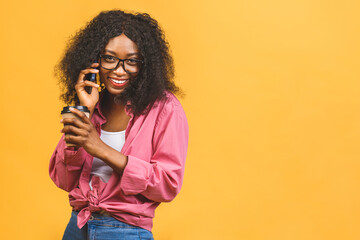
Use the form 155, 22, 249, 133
120, 156, 152, 195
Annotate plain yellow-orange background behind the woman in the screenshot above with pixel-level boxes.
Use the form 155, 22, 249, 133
0, 0, 360, 240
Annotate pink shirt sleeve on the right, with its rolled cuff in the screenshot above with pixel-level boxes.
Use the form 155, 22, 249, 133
120, 101, 189, 202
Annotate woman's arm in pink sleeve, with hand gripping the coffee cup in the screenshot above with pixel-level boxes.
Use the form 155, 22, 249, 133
62, 97, 189, 202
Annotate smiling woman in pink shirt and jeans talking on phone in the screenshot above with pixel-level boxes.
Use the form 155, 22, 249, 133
49, 10, 188, 239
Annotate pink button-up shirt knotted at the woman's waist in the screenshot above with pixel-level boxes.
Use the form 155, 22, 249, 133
49, 93, 189, 231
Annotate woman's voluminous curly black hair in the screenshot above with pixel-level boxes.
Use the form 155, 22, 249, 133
55, 10, 181, 115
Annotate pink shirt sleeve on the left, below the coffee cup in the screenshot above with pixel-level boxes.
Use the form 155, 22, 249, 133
49, 135, 85, 192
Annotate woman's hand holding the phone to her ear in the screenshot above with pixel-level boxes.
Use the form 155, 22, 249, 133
75, 63, 99, 116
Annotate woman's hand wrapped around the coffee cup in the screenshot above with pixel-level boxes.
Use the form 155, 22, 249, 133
61, 108, 104, 156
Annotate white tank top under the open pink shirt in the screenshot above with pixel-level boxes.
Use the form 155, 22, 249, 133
89, 129, 125, 189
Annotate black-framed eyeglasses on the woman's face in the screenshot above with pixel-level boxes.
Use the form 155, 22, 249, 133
99, 54, 144, 73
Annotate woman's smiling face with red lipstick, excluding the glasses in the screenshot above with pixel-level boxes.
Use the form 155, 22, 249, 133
99, 34, 141, 95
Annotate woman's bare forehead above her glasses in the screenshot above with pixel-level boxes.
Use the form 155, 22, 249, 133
105, 34, 139, 55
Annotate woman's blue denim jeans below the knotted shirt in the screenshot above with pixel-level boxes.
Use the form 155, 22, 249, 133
63, 211, 154, 240
